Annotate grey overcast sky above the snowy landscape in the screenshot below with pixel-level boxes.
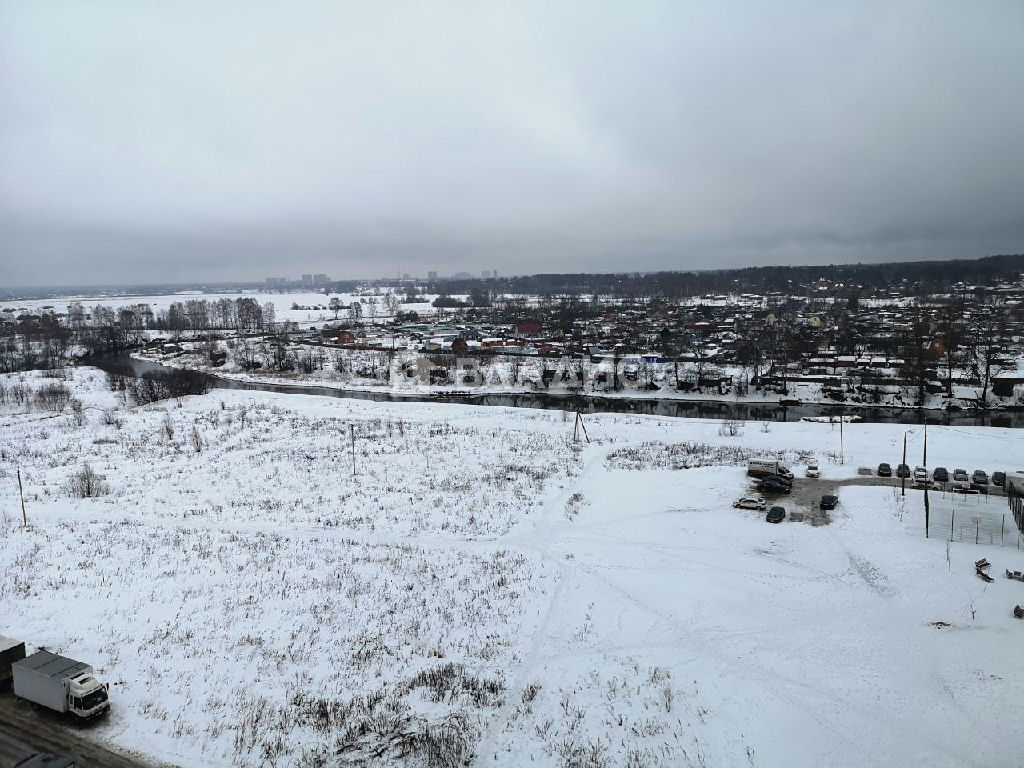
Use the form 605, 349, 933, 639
0, 0, 1024, 286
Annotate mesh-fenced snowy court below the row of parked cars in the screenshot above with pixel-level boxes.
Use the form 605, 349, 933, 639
926, 493, 1024, 549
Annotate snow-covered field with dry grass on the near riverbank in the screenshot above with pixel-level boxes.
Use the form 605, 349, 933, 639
0, 369, 1024, 767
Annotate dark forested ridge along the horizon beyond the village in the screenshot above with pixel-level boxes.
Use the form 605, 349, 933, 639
425, 254, 1024, 299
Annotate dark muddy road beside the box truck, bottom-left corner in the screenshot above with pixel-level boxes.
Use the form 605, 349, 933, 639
0, 690, 156, 768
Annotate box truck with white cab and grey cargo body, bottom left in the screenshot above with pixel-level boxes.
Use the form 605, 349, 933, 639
11, 650, 111, 720
